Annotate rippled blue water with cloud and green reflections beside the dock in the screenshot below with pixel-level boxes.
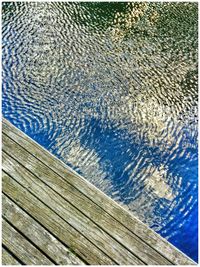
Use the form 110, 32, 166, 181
2, 2, 198, 260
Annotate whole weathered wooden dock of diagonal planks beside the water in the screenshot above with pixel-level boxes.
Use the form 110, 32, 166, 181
2, 119, 196, 265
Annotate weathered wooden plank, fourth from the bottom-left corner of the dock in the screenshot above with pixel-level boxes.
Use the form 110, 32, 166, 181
2, 171, 116, 265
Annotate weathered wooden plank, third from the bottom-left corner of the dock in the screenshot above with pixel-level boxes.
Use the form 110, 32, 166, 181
2, 195, 84, 265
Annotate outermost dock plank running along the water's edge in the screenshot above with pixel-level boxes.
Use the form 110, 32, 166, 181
3, 119, 196, 265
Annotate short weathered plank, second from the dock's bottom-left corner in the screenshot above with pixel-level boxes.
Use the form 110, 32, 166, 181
2, 219, 53, 265
